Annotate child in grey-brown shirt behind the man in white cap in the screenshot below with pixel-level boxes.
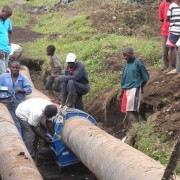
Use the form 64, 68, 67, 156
46, 45, 62, 99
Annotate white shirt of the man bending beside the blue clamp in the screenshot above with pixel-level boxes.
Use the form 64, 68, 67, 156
16, 98, 52, 127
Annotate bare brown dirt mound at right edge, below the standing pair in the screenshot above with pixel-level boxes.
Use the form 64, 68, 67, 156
144, 74, 180, 138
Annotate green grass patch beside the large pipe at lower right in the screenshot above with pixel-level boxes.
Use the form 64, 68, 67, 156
134, 121, 180, 174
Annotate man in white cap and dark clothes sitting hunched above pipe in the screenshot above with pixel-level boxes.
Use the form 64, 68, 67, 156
58, 53, 90, 110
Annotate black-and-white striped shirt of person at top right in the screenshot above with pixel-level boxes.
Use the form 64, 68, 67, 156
167, 2, 180, 35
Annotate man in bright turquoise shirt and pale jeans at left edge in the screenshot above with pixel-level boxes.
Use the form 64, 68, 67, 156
0, 6, 12, 75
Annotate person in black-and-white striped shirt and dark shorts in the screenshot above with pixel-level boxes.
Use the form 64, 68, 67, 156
166, 0, 180, 72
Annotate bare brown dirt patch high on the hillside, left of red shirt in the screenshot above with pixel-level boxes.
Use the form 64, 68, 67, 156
91, 1, 161, 38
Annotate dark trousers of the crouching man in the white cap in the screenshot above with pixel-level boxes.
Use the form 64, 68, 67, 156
60, 80, 90, 110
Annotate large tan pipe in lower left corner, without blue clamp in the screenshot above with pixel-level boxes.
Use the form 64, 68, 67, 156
0, 103, 43, 180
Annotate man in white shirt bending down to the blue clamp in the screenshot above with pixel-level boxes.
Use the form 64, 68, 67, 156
16, 98, 57, 159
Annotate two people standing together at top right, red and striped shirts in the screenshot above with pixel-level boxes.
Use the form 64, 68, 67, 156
158, 0, 180, 73
